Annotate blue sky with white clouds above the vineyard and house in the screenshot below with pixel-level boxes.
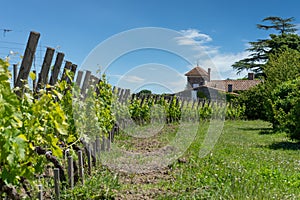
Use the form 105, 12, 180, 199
0, 0, 300, 93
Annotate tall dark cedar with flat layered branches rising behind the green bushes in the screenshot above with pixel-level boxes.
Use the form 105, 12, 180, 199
232, 17, 300, 76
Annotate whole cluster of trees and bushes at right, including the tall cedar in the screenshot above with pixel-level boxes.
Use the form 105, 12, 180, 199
232, 16, 300, 140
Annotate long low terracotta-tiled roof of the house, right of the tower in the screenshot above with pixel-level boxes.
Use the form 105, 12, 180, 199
206, 80, 261, 91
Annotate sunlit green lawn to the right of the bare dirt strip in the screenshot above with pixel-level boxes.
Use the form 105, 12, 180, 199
162, 121, 300, 199
